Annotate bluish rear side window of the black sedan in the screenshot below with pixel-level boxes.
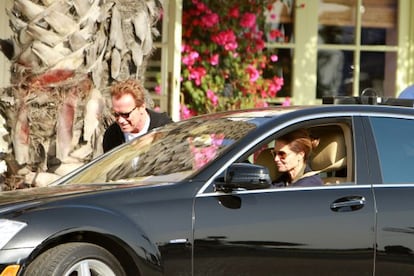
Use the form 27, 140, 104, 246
371, 117, 414, 183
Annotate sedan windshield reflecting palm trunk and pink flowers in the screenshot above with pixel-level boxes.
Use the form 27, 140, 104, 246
62, 116, 264, 184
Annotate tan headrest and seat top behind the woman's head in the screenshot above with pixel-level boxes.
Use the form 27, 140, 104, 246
310, 132, 346, 172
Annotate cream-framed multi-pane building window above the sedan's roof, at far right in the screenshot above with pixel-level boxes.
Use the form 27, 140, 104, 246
317, 0, 398, 98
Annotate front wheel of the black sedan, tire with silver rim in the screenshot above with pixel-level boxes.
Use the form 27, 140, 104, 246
24, 242, 126, 276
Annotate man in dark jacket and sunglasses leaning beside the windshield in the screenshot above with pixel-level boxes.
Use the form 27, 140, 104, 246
102, 79, 172, 152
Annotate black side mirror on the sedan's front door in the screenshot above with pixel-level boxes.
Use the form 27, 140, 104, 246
214, 163, 272, 193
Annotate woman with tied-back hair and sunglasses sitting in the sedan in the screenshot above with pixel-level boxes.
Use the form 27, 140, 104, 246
272, 129, 323, 187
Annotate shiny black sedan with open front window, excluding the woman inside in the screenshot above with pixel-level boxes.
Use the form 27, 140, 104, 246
0, 96, 414, 276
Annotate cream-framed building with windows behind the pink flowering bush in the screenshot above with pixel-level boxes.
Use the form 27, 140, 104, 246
0, 0, 414, 120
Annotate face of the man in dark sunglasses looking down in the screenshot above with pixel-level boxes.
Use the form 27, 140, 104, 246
112, 94, 146, 133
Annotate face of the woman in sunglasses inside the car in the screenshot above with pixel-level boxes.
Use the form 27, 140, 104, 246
273, 141, 304, 172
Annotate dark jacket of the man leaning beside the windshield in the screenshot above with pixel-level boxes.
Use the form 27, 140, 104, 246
102, 109, 172, 152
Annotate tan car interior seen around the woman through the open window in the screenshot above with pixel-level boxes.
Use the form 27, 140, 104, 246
255, 123, 354, 185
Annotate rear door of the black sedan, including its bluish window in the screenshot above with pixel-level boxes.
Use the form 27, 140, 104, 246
365, 116, 414, 275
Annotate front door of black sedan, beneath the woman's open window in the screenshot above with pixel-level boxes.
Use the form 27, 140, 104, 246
193, 119, 375, 275
